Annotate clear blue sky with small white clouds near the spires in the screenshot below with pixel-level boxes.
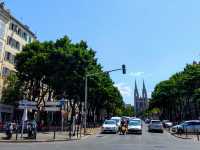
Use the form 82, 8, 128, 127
5, 0, 200, 104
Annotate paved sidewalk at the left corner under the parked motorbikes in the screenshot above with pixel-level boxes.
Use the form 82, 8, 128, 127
0, 128, 100, 143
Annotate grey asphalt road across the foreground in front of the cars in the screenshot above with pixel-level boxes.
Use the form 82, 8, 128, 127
0, 127, 200, 150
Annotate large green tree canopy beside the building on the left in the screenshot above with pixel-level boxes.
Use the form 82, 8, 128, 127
1, 36, 124, 122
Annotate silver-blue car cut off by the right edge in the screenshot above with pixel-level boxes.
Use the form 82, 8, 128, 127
172, 120, 200, 133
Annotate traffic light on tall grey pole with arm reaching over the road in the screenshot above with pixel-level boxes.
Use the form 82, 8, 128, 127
84, 64, 126, 135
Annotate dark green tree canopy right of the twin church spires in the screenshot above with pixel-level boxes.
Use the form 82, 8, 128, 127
150, 63, 200, 121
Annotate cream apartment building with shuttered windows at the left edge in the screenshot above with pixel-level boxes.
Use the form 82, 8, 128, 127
0, 2, 36, 120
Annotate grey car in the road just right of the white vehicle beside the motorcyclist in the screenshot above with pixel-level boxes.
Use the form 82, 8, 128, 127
148, 120, 163, 133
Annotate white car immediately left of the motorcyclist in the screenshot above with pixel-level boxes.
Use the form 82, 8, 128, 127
101, 120, 118, 133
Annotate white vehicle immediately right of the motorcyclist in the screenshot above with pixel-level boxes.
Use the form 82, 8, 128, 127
128, 118, 142, 134
